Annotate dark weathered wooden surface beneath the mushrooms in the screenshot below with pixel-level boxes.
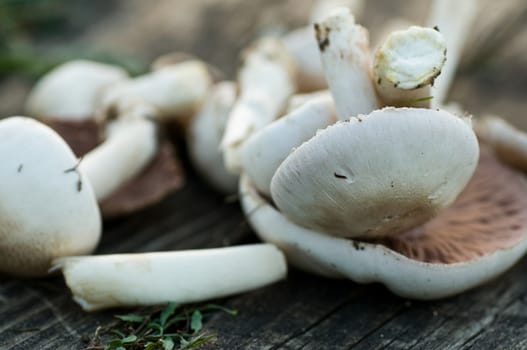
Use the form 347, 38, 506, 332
0, 170, 527, 350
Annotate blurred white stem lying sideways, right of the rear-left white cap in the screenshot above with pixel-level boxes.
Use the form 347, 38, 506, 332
99, 61, 211, 120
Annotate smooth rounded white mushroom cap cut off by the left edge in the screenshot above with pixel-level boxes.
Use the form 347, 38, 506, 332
0, 117, 101, 277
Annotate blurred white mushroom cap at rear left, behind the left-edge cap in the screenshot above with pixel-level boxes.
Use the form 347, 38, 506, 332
25, 60, 128, 120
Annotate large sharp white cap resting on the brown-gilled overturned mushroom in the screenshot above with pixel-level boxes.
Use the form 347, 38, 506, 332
271, 108, 479, 238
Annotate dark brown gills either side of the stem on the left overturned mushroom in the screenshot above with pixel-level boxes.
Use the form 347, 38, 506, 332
44, 118, 184, 218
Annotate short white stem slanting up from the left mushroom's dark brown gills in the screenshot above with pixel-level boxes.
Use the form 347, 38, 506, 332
79, 104, 158, 202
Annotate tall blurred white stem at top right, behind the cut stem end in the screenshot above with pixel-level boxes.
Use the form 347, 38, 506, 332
428, 0, 478, 108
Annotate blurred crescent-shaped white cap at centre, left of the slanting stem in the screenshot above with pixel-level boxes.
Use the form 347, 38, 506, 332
186, 81, 238, 193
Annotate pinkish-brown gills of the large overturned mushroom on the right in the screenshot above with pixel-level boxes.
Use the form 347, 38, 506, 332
374, 148, 527, 264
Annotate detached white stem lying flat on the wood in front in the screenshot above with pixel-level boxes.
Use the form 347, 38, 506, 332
52, 244, 287, 311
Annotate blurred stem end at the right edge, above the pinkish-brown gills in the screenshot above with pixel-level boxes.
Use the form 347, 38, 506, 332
474, 116, 527, 172
